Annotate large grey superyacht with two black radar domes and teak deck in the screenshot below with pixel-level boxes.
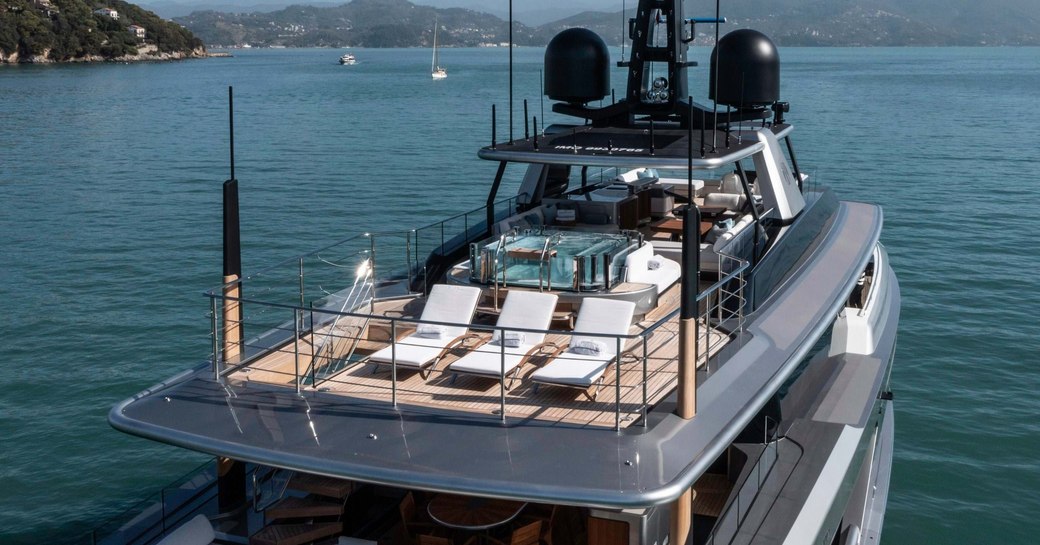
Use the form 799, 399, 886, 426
107, 0, 900, 545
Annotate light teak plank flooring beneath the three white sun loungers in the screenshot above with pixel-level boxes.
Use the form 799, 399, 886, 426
231, 285, 729, 427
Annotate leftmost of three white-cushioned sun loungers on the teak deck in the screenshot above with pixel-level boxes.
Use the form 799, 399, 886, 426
368, 284, 480, 379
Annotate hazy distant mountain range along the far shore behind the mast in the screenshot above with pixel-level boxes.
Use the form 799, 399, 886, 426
175, 0, 1040, 47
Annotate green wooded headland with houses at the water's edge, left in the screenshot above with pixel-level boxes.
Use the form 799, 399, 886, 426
0, 0, 205, 62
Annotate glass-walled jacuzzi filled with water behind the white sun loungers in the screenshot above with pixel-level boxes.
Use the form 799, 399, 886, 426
469, 228, 642, 291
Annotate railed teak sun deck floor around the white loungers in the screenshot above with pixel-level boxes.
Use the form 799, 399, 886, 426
227, 285, 732, 427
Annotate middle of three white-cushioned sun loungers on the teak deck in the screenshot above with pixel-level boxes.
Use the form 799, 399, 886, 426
448, 290, 558, 390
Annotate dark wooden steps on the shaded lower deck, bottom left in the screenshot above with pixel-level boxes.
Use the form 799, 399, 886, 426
250, 473, 354, 545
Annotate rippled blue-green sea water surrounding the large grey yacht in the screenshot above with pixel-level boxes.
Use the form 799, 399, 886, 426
0, 48, 1040, 544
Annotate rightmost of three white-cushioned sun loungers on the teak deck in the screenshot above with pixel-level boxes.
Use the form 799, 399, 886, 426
530, 297, 635, 399
